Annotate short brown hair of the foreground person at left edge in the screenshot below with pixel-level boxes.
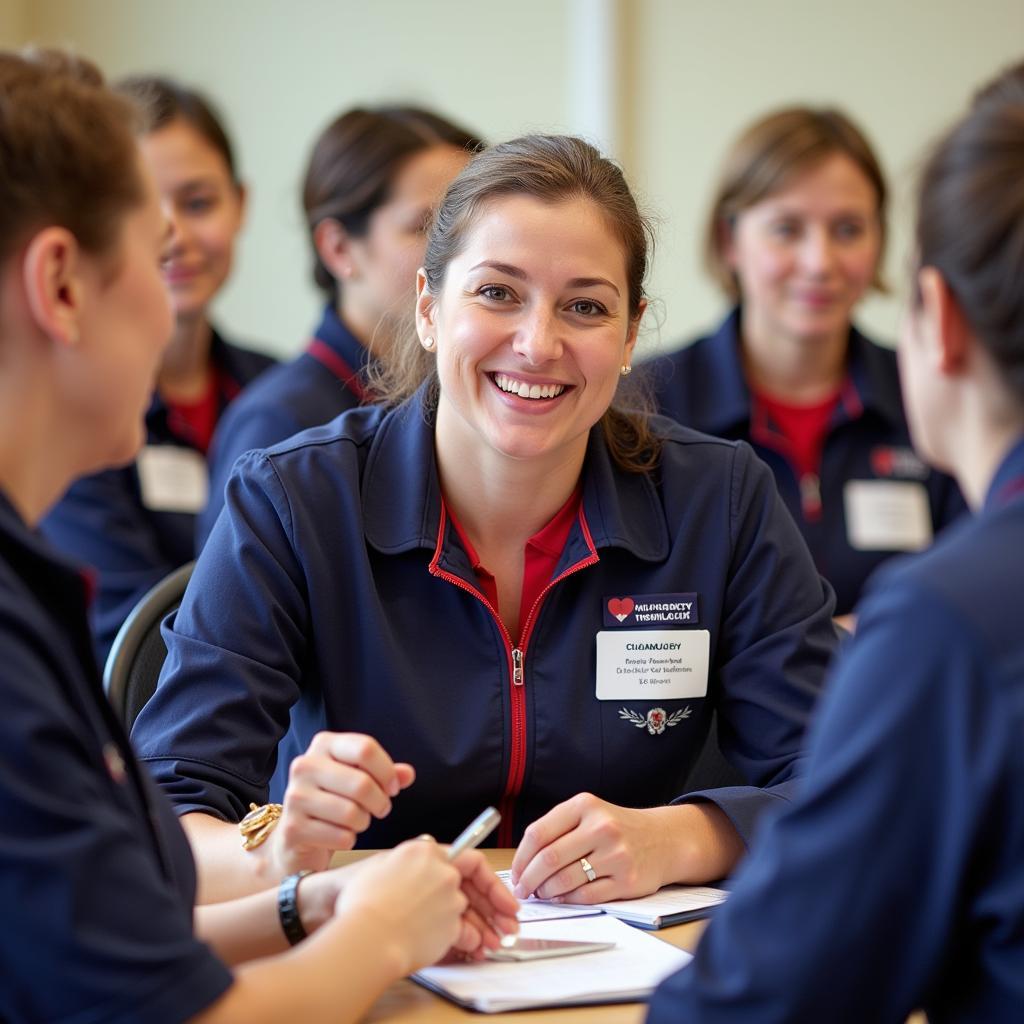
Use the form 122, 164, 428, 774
0, 50, 145, 272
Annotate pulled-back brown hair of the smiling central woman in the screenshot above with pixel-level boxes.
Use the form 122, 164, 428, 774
373, 135, 659, 472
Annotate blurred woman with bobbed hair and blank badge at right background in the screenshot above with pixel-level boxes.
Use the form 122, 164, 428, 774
647, 106, 964, 624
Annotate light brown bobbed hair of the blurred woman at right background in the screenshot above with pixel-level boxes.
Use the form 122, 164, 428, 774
705, 106, 887, 302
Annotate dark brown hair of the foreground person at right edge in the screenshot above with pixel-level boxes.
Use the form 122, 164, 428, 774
916, 62, 1024, 404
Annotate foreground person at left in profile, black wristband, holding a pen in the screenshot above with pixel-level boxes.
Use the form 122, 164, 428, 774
0, 46, 515, 1024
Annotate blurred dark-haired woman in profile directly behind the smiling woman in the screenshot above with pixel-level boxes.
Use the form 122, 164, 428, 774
197, 106, 482, 547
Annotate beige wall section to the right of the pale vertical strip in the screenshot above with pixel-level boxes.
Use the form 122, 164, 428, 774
633, 0, 1024, 346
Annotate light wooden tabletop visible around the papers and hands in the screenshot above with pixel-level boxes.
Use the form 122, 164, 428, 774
332, 850, 706, 1024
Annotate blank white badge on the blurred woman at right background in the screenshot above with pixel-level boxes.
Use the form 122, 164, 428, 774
843, 480, 932, 551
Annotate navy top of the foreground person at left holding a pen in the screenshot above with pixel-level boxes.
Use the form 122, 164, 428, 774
0, 495, 231, 1024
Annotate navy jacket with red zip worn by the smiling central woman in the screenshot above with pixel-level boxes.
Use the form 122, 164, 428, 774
133, 396, 836, 847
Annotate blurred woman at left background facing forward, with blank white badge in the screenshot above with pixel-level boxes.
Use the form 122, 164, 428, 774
43, 77, 273, 663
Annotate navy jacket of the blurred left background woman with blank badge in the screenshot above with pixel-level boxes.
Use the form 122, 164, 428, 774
41, 332, 274, 665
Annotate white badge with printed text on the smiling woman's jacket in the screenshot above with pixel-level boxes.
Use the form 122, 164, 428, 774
597, 630, 711, 700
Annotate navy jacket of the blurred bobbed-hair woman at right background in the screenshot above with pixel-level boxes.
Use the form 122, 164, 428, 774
644, 309, 966, 614
